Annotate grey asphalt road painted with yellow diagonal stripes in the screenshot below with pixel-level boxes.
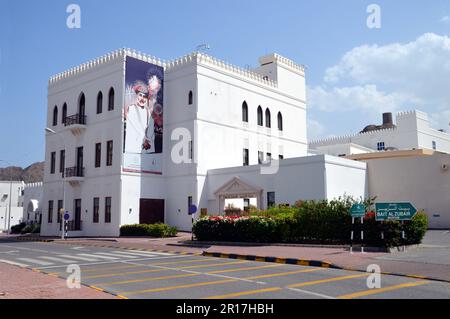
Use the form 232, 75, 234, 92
0, 241, 450, 299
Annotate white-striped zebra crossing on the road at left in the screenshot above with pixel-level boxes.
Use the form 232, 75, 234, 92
0, 250, 175, 268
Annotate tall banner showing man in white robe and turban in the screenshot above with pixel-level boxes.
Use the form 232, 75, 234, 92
123, 57, 164, 174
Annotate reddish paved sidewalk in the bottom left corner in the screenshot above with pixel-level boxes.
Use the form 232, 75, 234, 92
0, 263, 117, 300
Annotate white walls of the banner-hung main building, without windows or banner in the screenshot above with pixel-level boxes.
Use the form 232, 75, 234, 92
40, 49, 366, 236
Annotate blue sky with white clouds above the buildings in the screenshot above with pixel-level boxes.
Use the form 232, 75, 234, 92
0, 0, 450, 167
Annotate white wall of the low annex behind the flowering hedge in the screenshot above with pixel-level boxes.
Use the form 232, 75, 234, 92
207, 155, 366, 213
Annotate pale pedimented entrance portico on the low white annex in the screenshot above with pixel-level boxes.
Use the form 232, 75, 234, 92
214, 176, 263, 215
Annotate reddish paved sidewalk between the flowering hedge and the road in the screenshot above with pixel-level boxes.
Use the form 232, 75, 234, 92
8, 231, 450, 282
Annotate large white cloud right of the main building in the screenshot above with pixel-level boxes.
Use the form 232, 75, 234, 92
308, 32, 450, 126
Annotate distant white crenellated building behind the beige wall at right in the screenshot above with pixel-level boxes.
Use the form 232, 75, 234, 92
309, 111, 450, 156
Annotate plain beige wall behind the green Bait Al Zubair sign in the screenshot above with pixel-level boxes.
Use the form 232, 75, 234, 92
367, 154, 450, 228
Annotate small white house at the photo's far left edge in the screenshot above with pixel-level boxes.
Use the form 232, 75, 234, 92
0, 181, 24, 231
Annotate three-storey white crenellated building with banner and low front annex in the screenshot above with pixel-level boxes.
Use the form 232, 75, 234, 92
39, 49, 367, 236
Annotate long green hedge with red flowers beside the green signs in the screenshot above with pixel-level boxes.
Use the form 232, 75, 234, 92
193, 198, 428, 247
